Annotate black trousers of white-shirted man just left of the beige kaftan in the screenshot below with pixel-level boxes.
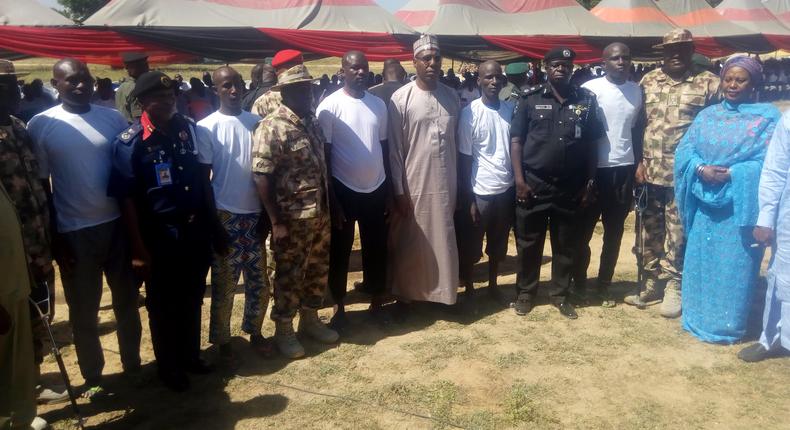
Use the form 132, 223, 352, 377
329, 178, 387, 304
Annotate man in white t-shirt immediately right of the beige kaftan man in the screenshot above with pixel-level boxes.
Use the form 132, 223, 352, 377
456, 61, 516, 297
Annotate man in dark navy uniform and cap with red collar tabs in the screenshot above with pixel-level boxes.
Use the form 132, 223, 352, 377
109, 71, 226, 391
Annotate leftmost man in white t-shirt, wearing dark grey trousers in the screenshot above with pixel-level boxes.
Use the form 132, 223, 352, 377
28, 58, 141, 397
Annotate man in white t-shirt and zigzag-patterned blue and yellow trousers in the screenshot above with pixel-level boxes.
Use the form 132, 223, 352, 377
197, 67, 272, 364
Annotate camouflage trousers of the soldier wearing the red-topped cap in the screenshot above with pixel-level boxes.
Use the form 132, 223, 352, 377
271, 214, 331, 321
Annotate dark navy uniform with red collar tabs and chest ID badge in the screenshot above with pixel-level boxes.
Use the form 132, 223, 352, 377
109, 114, 213, 380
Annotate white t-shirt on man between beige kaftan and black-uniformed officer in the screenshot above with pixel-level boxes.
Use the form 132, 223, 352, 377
458, 99, 515, 196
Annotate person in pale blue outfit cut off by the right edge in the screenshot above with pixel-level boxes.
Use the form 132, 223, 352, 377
738, 112, 790, 362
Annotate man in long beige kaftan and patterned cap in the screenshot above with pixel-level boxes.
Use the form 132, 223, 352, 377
387, 35, 460, 304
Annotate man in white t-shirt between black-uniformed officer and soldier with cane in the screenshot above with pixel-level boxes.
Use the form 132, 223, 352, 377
573, 43, 644, 307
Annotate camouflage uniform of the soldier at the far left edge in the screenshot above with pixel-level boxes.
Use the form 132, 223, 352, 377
0, 113, 55, 364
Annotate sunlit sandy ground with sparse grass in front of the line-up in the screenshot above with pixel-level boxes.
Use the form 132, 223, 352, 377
39, 215, 790, 429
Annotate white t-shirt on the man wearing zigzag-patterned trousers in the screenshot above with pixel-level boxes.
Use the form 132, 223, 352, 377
197, 111, 261, 214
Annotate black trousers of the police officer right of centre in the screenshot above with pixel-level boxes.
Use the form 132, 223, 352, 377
515, 192, 578, 304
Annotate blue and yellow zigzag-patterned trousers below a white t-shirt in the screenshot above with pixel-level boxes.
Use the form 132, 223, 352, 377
208, 210, 269, 345
